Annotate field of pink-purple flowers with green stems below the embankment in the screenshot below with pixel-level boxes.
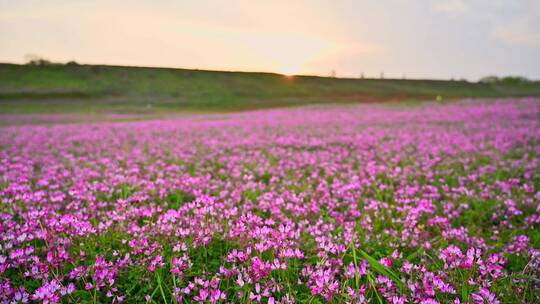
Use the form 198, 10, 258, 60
0, 99, 540, 303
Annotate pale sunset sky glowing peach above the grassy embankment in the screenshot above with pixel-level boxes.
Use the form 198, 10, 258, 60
0, 0, 540, 80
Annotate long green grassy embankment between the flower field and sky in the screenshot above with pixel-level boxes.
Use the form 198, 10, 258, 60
0, 64, 540, 113
